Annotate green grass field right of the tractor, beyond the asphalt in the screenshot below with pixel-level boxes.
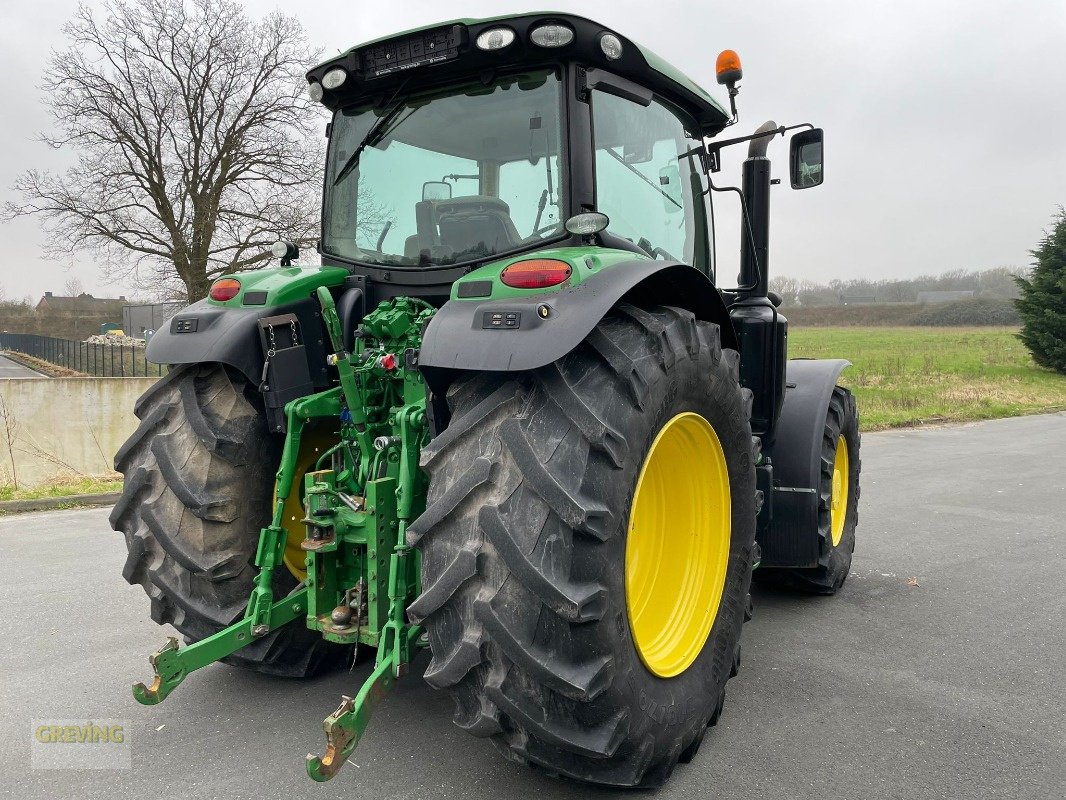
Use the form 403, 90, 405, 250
789, 327, 1066, 431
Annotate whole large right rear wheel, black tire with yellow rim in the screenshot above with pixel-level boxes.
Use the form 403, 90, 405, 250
408, 305, 756, 787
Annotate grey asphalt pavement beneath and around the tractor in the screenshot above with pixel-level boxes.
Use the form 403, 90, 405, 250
0, 414, 1066, 800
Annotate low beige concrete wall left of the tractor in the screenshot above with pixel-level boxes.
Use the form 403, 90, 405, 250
0, 378, 158, 486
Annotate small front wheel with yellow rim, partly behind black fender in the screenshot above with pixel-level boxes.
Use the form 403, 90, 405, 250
755, 386, 862, 594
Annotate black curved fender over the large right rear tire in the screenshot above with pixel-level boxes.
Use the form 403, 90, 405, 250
419, 259, 737, 395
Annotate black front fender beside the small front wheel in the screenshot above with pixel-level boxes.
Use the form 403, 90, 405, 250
757, 358, 851, 567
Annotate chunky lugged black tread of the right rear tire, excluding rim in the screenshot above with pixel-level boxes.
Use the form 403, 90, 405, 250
407, 304, 755, 787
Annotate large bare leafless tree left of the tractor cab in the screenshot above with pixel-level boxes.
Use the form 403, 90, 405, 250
4, 0, 323, 301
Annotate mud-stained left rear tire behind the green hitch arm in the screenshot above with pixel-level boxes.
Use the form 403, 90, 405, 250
111, 364, 350, 677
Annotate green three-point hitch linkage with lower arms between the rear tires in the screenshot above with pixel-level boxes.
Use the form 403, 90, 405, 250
133, 292, 434, 781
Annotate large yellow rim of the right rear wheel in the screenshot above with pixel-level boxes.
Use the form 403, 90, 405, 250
626, 412, 731, 677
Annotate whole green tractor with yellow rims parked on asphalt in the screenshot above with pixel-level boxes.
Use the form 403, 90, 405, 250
111, 14, 859, 786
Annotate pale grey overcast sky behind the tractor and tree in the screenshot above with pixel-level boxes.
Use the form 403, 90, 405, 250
0, 0, 1066, 298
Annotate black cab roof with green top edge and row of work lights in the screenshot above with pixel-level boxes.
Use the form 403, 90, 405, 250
307, 12, 730, 137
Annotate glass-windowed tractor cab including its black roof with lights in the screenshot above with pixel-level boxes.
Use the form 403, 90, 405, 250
308, 15, 730, 300
